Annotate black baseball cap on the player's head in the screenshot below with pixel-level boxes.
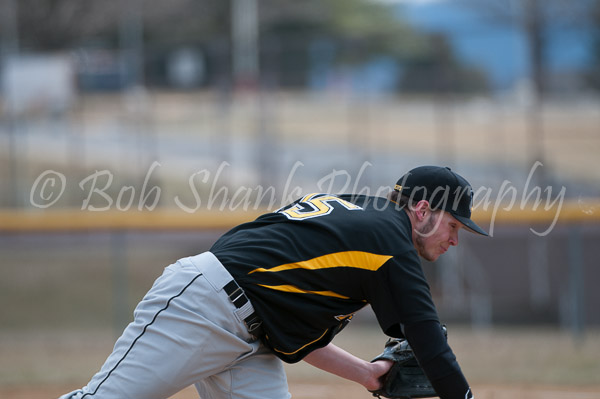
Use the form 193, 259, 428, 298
394, 166, 488, 236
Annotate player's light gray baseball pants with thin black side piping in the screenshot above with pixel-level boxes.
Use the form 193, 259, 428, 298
60, 252, 291, 399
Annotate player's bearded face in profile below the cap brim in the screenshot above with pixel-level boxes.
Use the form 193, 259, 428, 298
415, 211, 463, 261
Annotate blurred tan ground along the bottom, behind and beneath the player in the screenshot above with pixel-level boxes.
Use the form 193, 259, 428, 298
0, 325, 600, 399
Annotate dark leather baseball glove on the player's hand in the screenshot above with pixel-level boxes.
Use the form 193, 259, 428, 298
370, 327, 446, 399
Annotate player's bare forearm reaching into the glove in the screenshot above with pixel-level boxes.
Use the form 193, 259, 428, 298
304, 343, 391, 389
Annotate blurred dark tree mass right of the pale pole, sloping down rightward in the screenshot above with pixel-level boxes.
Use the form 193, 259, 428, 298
261, 0, 488, 92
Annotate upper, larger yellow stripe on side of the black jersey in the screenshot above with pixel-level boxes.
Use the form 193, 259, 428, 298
248, 251, 392, 274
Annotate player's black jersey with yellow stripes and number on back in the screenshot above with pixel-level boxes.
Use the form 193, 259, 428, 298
210, 194, 438, 362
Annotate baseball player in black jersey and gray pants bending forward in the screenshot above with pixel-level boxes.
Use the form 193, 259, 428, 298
61, 166, 487, 399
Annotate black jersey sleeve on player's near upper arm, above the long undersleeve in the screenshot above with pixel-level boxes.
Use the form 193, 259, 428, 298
369, 251, 439, 338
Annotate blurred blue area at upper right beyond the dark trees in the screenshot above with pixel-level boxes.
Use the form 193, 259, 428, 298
392, 0, 591, 89
